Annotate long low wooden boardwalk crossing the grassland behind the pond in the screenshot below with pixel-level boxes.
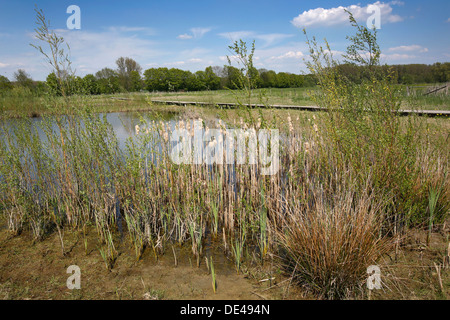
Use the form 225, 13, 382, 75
151, 100, 450, 117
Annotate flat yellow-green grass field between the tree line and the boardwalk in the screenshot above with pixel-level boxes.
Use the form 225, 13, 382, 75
0, 86, 450, 118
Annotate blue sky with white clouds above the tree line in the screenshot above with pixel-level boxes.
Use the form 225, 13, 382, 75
0, 0, 450, 80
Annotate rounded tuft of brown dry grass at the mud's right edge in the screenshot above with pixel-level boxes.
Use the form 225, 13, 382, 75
279, 182, 393, 299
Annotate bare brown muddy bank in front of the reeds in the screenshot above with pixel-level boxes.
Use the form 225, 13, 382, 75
0, 227, 292, 300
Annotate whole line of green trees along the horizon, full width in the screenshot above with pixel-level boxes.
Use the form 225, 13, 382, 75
0, 57, 450, 95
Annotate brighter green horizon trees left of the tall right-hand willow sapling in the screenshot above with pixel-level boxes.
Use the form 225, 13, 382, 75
0, 57, 315, 95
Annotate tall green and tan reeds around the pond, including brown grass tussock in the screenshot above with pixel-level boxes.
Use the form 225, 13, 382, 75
0, 105, 450, 298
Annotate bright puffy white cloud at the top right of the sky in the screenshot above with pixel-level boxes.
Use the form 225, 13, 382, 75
291, 1, 403, 28
